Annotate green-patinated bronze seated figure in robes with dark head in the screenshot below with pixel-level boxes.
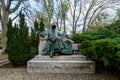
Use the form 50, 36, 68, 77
40, 24, 73, 57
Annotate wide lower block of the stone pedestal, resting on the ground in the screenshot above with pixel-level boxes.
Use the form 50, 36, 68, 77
27, 59, 95, 74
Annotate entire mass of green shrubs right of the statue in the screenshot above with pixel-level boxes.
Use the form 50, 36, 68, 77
71, 21, 120, 69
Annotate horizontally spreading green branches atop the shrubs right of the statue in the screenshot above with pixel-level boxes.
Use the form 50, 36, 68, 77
71, 28, 117, 43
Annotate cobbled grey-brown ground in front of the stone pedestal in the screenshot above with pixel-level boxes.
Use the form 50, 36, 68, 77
0, 68, 118, 80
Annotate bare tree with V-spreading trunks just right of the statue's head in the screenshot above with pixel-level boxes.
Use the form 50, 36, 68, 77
68, 0, 84, 34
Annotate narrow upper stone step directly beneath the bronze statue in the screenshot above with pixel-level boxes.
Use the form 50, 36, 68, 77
34, 55, 86, 61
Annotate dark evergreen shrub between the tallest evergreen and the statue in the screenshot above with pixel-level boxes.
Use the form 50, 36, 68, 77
30, 19, 45, 58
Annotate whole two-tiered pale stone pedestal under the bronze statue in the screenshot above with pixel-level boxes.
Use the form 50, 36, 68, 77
27, 55, 95, 74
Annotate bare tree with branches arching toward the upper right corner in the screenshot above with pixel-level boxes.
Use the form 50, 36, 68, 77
82, 0, 120, 32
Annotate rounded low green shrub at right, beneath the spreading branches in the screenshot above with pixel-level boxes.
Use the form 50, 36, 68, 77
94, 38, 116, 66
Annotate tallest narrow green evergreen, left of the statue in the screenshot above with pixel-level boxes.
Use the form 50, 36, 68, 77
18, 12, 29, 65
